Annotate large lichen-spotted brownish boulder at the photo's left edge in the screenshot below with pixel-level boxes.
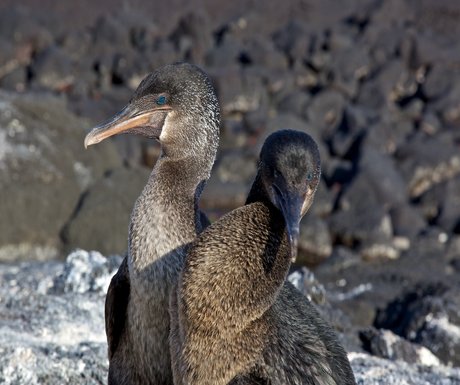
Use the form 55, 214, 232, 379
0, 94, 120, 260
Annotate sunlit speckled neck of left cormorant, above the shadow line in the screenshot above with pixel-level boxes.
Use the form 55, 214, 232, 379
128, 156, 210, 274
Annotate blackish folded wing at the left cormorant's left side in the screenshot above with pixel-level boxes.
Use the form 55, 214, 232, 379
105, 257, 131, 360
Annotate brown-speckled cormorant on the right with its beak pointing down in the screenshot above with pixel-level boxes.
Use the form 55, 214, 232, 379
170, 130, 355, 385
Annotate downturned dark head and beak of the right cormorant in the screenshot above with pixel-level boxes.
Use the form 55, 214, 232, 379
259, 130, 321, 260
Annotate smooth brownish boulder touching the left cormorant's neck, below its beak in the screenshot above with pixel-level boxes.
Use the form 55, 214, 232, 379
63, 168, 149, 255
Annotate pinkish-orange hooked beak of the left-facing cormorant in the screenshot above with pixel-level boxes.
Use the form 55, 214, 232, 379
85, 104, 172, 148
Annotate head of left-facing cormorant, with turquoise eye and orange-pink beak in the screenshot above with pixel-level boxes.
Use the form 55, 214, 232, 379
85, 63, 219, 156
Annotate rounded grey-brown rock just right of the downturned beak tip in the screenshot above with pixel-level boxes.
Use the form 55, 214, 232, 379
296, 214, 332, 266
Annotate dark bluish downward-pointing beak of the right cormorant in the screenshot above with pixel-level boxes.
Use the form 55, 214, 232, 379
275, 188, 304, 262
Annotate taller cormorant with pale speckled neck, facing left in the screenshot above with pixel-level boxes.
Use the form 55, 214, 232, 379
85, 64, 219, 385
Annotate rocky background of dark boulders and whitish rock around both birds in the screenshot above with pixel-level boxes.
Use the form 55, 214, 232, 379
0, 0, 460, 384
